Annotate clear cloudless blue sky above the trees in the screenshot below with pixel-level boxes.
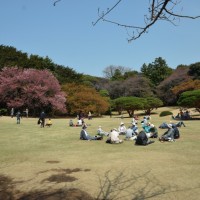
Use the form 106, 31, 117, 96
0, 0, 200, 77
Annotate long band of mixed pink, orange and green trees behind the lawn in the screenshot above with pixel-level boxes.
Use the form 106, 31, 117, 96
0, 46, 200, 116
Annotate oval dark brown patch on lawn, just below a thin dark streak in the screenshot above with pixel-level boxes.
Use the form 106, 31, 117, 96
42, 174, 78, 183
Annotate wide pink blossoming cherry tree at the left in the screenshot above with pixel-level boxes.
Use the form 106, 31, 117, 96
0, 67, 66, 115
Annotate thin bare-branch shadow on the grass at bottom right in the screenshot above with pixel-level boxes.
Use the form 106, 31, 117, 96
96, 170, 199, 200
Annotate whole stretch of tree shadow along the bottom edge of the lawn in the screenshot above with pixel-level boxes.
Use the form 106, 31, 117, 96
0, 170, 200, 200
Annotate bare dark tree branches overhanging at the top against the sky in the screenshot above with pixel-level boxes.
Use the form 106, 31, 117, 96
53, 0, 200, 42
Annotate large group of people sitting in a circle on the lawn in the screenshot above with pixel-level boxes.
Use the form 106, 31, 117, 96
80, 116, 185, 145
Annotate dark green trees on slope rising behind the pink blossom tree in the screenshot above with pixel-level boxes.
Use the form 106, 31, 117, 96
0, 45, 83, 84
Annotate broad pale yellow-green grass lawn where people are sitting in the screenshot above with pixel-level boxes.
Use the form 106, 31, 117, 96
0, 108, 200, 200
